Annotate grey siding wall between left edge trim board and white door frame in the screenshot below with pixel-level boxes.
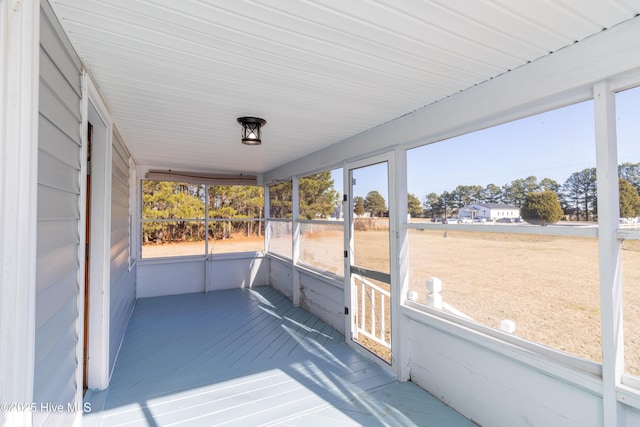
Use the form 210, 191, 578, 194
34, 1, 82, 425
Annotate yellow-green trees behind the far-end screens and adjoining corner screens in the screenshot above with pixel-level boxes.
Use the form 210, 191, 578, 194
142, 171, 339, 243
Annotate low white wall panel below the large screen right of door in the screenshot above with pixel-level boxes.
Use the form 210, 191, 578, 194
403, 310, 604, 427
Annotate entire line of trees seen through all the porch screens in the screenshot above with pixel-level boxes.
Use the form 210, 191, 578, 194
142, 162, 640, 242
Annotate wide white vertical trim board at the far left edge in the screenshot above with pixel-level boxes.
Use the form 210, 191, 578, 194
0, 0, 40, 426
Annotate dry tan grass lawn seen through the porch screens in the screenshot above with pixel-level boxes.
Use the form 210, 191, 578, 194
143, 229, 640, 375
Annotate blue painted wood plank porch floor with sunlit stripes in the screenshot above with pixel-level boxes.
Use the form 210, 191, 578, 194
83, 287, 474, 427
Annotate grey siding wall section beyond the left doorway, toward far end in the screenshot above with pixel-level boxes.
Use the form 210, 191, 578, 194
109, 132, 136, 372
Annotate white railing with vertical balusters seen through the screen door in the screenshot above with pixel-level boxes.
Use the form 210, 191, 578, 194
354, 276, 391, 348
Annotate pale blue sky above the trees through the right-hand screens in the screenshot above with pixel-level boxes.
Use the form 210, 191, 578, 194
332, 87, 640, 206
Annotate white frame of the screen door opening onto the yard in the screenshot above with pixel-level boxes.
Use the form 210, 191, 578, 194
343, 151, 398, 373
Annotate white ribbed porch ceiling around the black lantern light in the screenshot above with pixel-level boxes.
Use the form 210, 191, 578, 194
49, 0, 640, 173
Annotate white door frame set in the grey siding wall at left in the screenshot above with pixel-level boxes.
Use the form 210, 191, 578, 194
77, 71, 113, 394
